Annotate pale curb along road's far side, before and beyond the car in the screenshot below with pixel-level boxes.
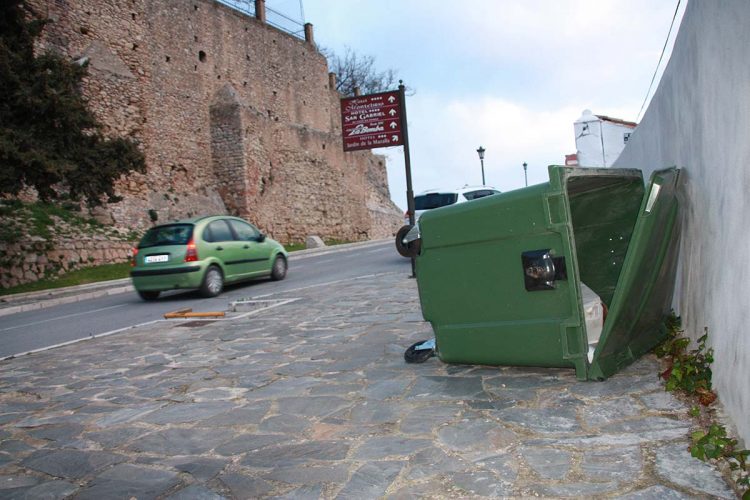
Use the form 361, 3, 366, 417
0, 238, 392, 317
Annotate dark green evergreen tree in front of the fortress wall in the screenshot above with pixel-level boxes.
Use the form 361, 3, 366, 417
0, 0, 145, 206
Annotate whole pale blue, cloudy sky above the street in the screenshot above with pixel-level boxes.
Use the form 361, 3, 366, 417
266, 0, 687, 209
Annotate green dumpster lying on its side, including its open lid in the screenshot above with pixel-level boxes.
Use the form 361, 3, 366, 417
416, 166, 680, 380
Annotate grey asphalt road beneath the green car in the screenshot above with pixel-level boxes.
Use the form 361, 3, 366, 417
0, 241, 411, 359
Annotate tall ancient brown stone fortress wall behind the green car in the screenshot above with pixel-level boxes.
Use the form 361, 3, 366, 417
29, 0, 402, 242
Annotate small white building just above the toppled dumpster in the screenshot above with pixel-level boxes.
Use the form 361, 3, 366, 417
566, 109, 636, 167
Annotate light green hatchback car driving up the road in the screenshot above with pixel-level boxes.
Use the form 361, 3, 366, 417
130, 215, 287, 300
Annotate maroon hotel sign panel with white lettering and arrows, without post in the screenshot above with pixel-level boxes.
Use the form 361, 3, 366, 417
341, 91, 404, 151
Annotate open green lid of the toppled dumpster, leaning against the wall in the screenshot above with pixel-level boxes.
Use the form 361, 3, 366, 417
588, 168, 680, 379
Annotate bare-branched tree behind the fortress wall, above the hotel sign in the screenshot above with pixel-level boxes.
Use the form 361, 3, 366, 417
321, 47, 396, 97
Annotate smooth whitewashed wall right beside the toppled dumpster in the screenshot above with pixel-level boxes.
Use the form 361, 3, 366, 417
615, 0, 750, 445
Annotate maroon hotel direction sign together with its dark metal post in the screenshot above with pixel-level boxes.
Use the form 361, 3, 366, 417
341, 80, 416, 277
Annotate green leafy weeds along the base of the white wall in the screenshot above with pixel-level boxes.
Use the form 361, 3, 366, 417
655, 314, 750, 500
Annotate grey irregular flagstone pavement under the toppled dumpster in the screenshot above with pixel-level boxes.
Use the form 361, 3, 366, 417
0, 273, 735, 499
